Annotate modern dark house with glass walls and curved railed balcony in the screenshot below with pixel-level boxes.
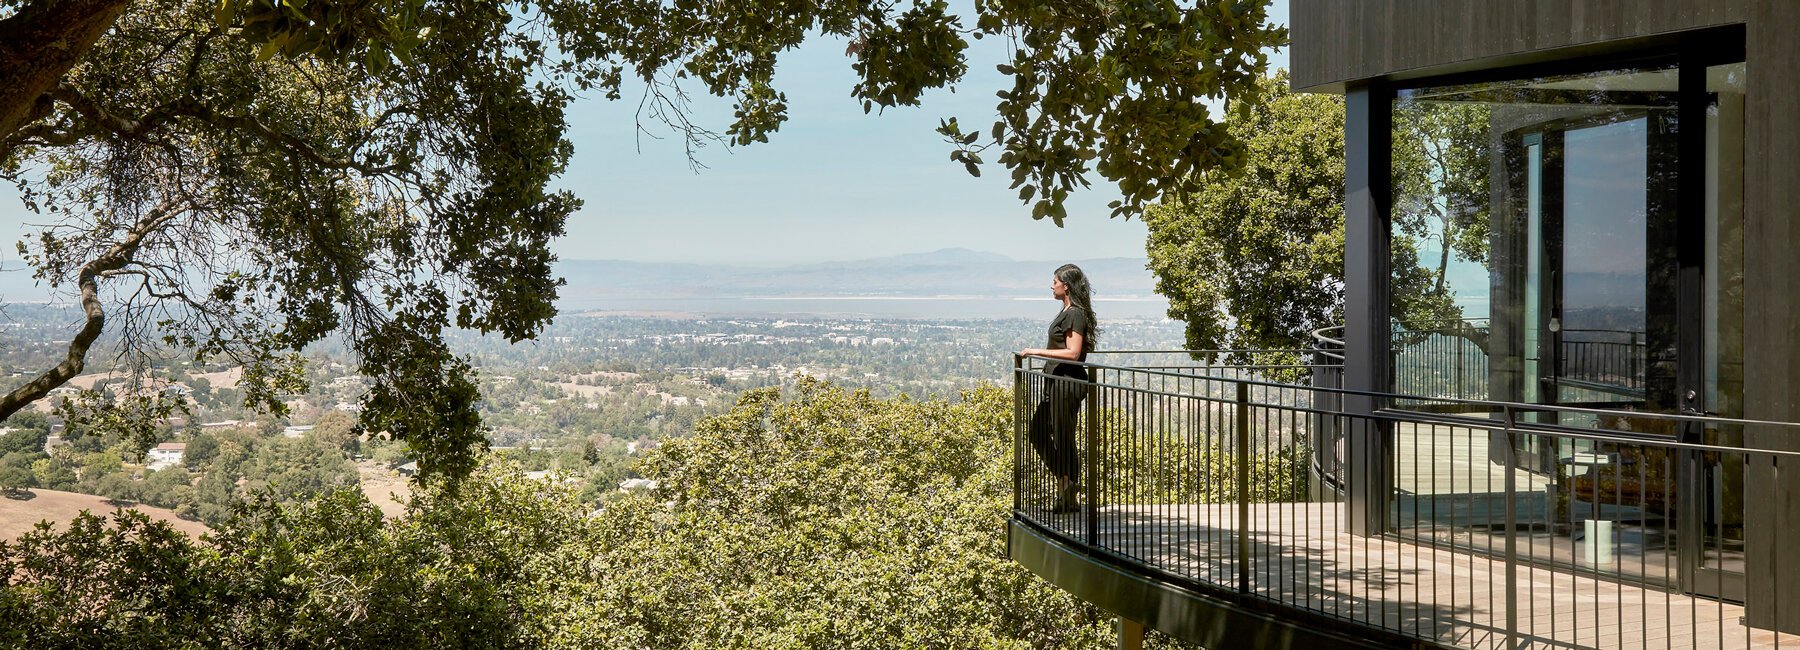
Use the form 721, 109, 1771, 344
1008, 0, 1800, 648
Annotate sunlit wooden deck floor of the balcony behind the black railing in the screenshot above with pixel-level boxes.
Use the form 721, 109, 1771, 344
1026, 502, 1800, 648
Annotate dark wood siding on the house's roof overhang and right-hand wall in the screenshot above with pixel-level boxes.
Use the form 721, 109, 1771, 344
1289, 0, 1800, 632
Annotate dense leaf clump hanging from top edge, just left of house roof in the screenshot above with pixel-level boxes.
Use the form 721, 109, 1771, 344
945, 0, 1287, 225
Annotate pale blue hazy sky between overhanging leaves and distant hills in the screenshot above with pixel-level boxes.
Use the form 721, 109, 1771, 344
0, 0, 1287, 268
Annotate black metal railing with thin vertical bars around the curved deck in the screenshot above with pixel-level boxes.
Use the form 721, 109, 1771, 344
1013, 351, 1800, 648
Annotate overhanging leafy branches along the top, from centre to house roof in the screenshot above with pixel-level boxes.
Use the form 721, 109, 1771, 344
547, 0, 1287, 223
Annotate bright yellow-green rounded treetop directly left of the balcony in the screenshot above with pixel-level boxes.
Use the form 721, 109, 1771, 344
594, 380, 1109, 648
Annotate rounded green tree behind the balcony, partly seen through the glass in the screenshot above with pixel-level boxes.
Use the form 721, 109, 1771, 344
1145, 72, 1487, 351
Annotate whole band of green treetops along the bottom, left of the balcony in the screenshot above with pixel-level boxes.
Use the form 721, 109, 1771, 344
0, 380, 1209, 648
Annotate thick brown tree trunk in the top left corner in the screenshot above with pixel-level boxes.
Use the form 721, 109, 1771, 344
0, 0, 130, 142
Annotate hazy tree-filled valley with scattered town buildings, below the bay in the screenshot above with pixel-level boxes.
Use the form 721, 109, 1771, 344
0, 304, 1183, 520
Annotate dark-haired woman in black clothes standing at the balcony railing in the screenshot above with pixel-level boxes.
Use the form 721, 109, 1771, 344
1019, 265, 1098, 511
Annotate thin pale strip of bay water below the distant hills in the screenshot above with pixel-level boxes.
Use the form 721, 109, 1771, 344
569, 295, 1168, 322
